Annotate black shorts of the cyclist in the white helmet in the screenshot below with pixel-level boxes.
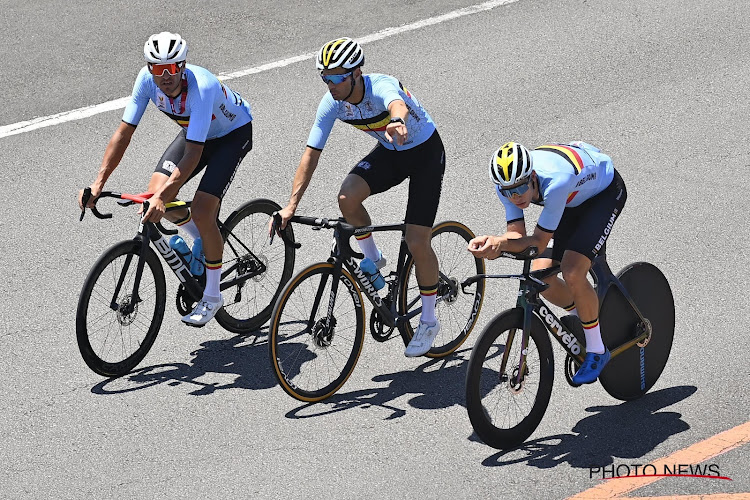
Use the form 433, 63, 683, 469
154, 122, 253, 199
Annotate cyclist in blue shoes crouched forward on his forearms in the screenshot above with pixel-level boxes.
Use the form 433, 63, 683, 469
469, 141, 627, 384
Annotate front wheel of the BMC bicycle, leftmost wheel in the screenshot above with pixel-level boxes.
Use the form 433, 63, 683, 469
76, 240, 166, 377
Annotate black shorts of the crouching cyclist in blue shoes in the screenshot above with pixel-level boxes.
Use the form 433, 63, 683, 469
552, 170, 628, 262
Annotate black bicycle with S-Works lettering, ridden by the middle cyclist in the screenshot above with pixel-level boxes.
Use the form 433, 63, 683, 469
268, 215, 484, 402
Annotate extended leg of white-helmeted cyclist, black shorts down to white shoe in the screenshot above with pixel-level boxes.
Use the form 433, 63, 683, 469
183, 122, 253, 326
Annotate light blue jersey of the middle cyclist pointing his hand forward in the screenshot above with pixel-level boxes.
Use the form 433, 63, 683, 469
307, 74, 435, 151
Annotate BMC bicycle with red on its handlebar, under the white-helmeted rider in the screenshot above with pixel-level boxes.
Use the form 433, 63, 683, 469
76, 188, 295, 377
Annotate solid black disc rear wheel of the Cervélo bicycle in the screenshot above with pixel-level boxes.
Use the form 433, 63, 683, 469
599, 262, 675, 401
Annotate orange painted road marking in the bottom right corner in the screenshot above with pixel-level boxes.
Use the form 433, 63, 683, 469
568, 422, 750, 500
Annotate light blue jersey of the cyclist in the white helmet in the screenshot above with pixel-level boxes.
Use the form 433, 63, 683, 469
122, 64, 253, 144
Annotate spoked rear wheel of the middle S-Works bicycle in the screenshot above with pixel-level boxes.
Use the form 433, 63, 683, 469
399, 221, 484, 358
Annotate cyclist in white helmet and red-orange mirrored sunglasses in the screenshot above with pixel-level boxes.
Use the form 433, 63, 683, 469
78, 32, 253, 326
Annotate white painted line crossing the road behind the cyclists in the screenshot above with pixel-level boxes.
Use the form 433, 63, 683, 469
0, 0, 518, 139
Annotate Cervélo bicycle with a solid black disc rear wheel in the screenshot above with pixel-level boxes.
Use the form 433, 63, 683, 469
462, 247, 675, 449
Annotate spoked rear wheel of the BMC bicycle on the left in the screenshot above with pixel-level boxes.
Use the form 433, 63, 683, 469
216, 199, 295, 333
